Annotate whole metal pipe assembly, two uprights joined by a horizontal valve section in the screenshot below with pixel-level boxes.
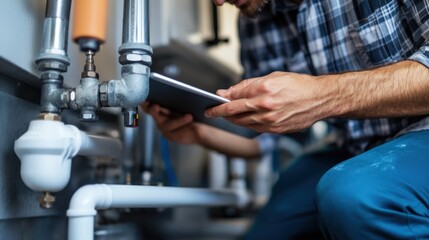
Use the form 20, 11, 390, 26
36, 0, 152, 124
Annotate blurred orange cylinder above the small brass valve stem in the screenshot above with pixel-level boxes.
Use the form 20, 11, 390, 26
72, 0, 108, 42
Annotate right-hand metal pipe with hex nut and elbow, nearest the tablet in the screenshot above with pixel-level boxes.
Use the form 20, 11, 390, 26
115, 0, 152, 127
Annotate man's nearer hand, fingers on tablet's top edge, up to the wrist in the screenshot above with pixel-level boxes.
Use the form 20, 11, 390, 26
205, 72, 334, 133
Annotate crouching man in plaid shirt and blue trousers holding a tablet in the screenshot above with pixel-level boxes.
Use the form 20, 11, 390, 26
146, 0, 429, 239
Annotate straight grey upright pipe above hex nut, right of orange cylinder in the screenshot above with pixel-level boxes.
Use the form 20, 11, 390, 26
122, 0, 150, 45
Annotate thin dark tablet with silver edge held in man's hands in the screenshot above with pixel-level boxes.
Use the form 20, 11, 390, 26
147, 73, 260, 138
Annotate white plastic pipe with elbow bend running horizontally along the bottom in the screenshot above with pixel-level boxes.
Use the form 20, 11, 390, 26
67, 184, 249, 240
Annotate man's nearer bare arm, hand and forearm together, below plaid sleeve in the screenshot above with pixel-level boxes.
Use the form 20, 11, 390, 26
205, 60, 429, 133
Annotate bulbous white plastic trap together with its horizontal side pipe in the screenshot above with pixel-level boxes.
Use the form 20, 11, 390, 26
14, 120, 122, 192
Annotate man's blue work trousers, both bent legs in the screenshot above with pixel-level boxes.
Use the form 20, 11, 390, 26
246, 131, 429, 240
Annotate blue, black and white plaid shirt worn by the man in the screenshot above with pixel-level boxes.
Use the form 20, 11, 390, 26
239, 0, 429, 153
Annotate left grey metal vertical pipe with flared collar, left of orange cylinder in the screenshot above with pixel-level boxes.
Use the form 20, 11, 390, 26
36, 0, 71, 65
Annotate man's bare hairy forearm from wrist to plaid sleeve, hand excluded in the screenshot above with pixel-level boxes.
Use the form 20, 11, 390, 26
318, 61, 429, 118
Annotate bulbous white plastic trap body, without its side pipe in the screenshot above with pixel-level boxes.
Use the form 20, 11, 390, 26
14, 120, 79, 192
